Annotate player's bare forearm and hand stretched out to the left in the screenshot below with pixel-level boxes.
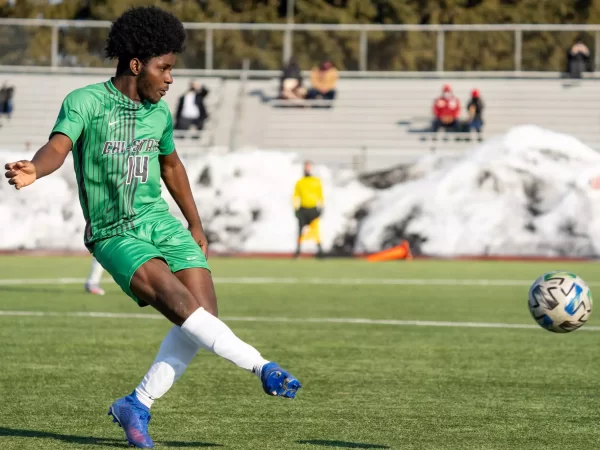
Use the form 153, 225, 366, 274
4, 134, 72, 189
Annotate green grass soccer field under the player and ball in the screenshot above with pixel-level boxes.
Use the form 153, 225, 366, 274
0, 257, 600, 450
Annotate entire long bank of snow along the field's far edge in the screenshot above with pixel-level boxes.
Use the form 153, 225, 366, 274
0, 126, 600, 256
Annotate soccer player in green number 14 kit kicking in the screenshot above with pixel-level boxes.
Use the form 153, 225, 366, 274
6, 7, 301, 448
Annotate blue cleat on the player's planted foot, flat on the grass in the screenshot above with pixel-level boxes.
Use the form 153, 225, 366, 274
108, 392, 154, 448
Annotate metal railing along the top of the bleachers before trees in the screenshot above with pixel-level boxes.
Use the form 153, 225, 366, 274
0, 18, 600, 75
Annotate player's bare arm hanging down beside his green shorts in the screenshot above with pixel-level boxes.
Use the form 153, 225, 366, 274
160, 151, 208, 255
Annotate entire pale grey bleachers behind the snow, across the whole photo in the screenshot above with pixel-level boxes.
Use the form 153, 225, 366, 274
0, 74, 600, 170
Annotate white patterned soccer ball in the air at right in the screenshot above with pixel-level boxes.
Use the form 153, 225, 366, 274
529, 271, 592, 333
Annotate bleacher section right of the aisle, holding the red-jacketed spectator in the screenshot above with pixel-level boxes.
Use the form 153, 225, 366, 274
236, 79, 600, 169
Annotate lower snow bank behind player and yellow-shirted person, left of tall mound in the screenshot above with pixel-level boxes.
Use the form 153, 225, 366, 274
0, 151, 373, 252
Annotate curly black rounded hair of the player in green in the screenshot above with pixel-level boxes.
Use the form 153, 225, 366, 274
106, 6, 185, 70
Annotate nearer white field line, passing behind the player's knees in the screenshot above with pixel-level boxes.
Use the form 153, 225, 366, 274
0, 310, 600, 331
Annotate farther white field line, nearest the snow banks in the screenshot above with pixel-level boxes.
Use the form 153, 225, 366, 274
0, 277, 600, 286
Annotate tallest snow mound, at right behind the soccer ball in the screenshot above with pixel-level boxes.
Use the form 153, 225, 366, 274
355, 126, 600, 256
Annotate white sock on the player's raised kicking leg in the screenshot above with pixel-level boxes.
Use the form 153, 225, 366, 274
181, 308, 269, 377
